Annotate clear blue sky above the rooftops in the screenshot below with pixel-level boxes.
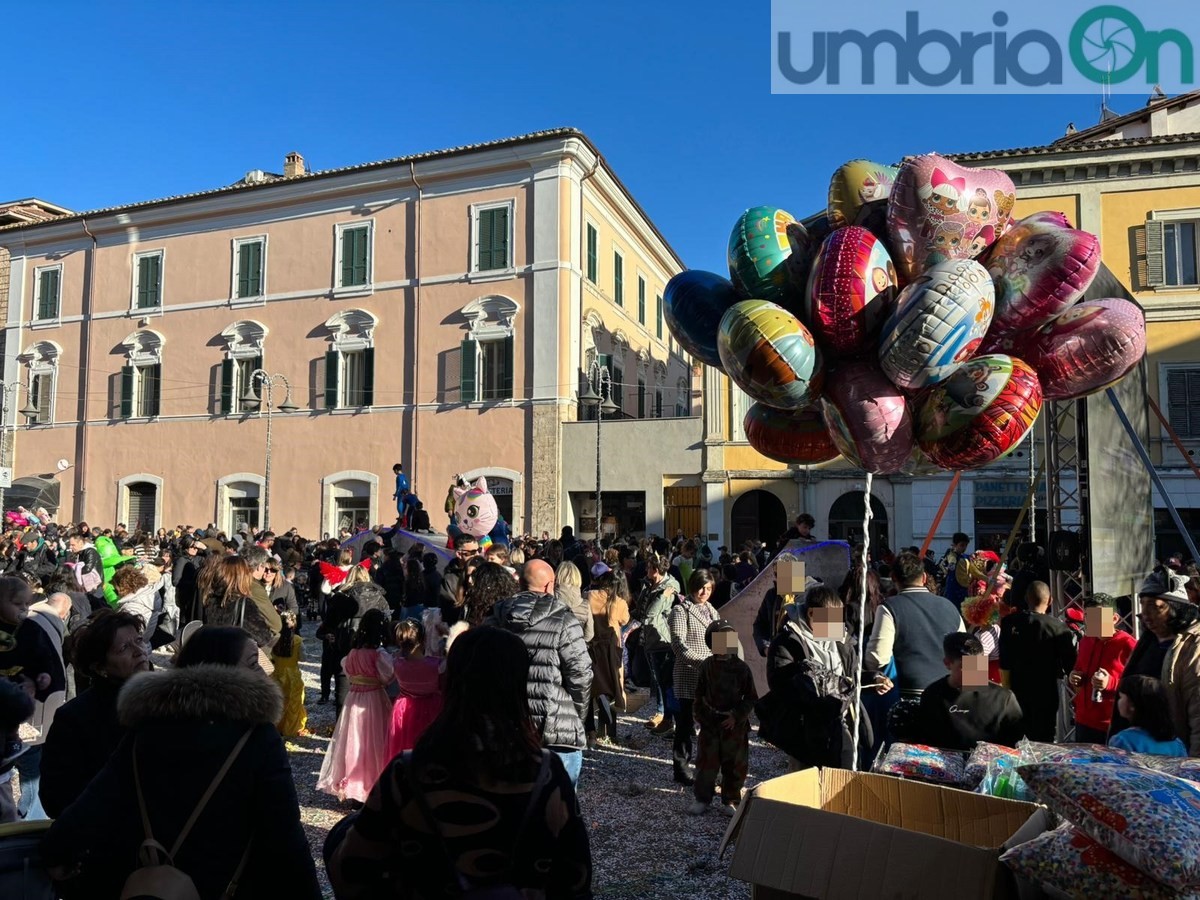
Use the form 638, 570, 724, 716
0, 0, 1145, 270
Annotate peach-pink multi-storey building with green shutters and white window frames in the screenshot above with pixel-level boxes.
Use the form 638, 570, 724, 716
0, 130, 701, 535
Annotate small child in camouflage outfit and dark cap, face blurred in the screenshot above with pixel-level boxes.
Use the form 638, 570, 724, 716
688, 620, 758, 815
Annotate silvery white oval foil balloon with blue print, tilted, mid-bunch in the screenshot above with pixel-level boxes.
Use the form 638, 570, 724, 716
880, 259, 995, 390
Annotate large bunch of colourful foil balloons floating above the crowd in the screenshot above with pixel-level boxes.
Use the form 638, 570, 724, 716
664, 154, 1146, 474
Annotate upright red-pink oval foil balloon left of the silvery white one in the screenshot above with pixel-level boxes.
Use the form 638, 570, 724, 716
802, 226, 896, 356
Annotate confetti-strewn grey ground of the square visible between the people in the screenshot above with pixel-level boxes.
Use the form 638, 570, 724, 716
288, 623, 786, 900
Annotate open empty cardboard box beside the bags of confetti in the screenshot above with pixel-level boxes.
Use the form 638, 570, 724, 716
721, 769, 1045, 900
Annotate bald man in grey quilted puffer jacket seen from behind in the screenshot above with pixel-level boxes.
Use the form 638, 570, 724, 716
484, 559, 592, 782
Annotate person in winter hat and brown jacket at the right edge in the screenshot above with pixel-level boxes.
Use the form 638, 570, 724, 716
1109, 570, 1200, 756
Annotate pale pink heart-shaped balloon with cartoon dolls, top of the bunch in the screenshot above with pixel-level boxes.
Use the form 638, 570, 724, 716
888, 154, 1016, 281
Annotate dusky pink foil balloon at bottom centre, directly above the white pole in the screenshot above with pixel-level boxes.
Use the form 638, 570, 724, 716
821, 360, 913, 475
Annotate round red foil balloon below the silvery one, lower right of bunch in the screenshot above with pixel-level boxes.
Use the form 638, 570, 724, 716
917, 355, 1042, 469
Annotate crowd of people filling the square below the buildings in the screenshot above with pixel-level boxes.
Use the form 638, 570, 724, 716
0, 508, 1200, 899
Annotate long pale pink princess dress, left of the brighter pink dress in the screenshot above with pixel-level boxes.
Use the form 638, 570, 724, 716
317, 648, 394, 803
